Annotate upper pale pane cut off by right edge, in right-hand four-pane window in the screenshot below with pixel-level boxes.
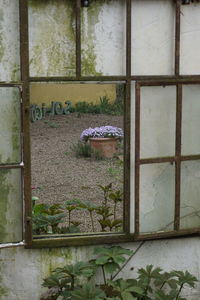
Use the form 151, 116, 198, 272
182, 85, 200, 155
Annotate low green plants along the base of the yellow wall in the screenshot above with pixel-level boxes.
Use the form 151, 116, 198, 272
70, 96, 123, 115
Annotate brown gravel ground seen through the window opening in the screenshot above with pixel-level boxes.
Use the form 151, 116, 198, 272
31, 113, 123, 232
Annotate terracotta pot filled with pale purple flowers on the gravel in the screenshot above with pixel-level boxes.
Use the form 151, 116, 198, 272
80, 126, 124, 158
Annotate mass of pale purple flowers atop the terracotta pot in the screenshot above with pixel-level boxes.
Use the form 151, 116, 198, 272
80, 126, 124, 142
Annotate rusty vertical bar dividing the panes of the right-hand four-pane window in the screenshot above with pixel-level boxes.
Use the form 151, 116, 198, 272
174, 84, 182, 231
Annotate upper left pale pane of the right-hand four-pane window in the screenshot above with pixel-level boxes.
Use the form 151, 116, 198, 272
140, 86, 176, 158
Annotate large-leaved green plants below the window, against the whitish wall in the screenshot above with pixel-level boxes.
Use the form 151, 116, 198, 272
40, 246, 197, 300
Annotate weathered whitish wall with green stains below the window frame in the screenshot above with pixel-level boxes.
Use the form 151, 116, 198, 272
0, 238, 200, 300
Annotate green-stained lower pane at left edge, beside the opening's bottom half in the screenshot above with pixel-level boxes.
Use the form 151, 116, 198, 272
0, 169, 23, 243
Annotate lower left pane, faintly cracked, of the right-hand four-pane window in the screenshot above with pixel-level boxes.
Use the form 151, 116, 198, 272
140, 163, 175, 233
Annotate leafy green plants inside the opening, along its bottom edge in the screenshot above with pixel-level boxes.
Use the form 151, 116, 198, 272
32, 179, 123, 234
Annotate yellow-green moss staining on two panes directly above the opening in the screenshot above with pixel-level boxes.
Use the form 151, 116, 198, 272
29, 0, 113, 76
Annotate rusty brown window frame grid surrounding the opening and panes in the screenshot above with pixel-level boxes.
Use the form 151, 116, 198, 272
12, 0, 200, 248
